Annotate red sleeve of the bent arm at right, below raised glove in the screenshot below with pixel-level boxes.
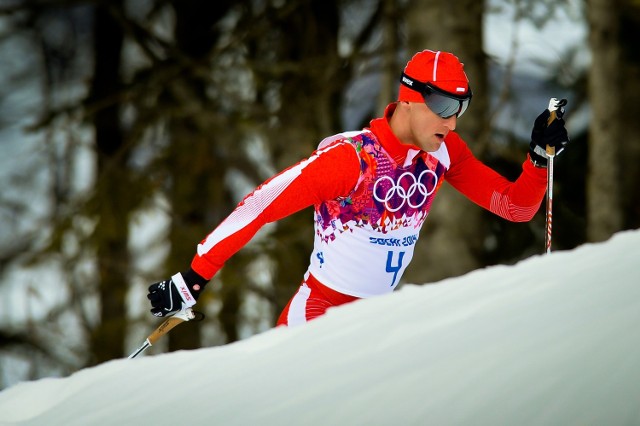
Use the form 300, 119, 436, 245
445, 133, 547, 222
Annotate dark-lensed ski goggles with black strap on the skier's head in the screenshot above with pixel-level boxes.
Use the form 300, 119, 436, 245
400, 73, 473, 118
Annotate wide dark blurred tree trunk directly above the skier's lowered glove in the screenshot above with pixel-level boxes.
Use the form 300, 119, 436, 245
160, 0, 239, 349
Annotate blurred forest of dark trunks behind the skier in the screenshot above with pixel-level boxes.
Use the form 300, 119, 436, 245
0, 0, 640, 389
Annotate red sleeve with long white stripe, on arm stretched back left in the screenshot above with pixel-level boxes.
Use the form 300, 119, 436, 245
191, 142, 360, 279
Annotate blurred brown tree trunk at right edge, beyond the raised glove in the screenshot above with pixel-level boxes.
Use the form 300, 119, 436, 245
587, 0, 640, 241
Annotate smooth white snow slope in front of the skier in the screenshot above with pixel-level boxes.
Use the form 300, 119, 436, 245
0, 231, 640, 426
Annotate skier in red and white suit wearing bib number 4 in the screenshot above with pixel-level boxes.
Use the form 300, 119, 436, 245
147, 50, 569, 326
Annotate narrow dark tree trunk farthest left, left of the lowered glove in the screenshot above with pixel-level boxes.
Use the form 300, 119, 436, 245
89, 2, 131, 363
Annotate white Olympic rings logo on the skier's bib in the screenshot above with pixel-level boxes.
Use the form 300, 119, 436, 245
373, 169, 438, 213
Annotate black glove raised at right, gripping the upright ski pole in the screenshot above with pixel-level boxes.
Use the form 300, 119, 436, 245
529, 99, 569, 167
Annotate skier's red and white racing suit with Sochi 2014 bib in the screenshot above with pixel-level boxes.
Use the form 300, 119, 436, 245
191, 104, 547, 325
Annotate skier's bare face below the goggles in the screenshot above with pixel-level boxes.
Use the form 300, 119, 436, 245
409, 102, 458, 152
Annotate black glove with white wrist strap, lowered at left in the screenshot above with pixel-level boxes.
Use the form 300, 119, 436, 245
147, 269, 209, 317
